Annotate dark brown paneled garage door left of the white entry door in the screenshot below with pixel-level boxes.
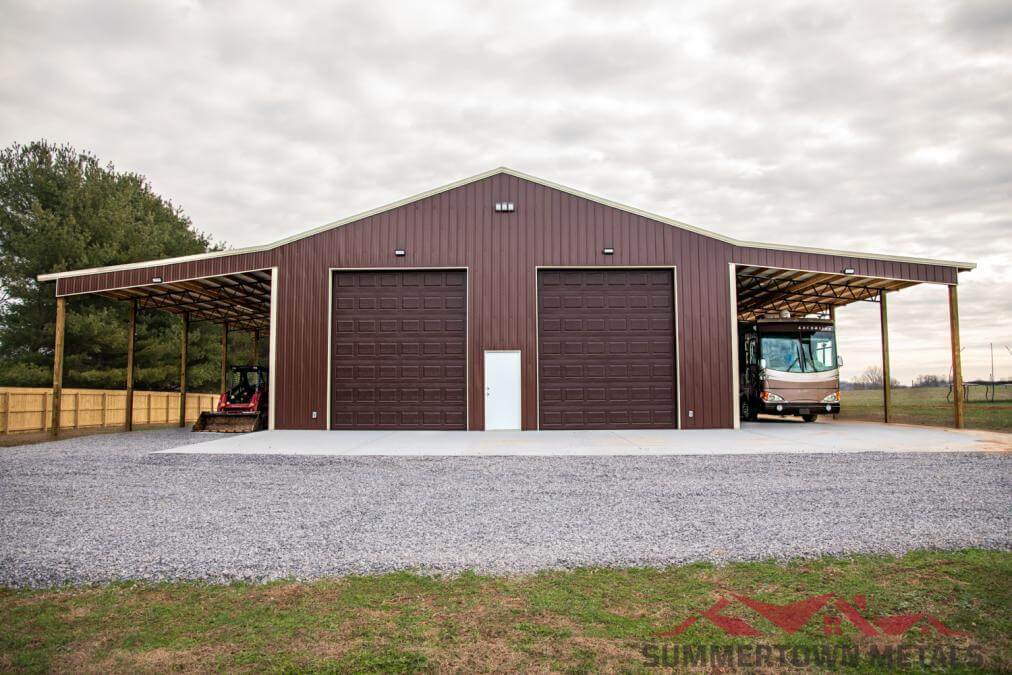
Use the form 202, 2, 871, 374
331, 270, 468, 429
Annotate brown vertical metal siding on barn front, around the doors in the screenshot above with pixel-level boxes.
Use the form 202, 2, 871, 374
49, 174, 955, 429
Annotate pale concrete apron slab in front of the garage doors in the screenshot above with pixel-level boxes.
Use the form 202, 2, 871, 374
159, 421, 1012, 456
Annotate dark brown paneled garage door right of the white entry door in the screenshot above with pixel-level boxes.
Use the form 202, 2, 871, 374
537, 269, 676, 429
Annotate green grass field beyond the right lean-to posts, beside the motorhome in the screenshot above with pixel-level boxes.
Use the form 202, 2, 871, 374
840, 387, 1012, 431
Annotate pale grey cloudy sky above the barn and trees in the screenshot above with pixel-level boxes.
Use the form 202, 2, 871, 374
0, 0, 1012, 381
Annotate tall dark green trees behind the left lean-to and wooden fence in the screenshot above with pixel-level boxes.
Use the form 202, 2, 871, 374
0, 141, 252, 392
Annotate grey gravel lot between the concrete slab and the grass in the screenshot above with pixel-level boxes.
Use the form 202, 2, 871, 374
0, 430, 1012, 586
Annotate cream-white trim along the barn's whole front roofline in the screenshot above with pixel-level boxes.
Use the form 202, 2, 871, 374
36, 166, 977, 281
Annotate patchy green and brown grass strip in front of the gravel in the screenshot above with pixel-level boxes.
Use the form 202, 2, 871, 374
0, 551, 1012, 673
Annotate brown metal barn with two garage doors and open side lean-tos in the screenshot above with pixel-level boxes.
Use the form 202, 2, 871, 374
38, 168, 974, 429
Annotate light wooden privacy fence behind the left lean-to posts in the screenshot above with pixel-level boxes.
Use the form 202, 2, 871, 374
0, 387, 219, 434
